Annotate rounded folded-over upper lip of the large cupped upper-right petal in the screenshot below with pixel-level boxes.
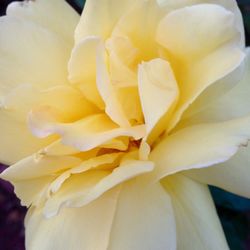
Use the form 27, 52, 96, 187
157, 4, 238, 61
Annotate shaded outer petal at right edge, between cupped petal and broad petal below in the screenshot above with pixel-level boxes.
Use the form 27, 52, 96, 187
180, 49, 250, 127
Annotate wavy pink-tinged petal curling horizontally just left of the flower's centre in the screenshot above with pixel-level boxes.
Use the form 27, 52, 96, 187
29, 113, 145, 151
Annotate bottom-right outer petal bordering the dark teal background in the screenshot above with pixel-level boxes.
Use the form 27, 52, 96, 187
163, 175, 229, 250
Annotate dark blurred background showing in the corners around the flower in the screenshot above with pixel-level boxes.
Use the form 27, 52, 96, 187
0, 0, 250, 250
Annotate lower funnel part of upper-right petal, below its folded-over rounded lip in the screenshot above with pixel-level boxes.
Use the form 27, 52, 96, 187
168, 46, 244, 130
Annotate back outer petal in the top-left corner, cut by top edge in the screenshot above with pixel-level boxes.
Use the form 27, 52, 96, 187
7, 0, 79, 43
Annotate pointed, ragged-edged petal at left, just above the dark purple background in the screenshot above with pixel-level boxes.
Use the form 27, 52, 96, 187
0, 154, 81, 206
